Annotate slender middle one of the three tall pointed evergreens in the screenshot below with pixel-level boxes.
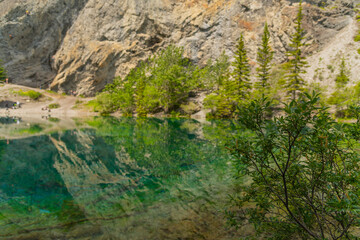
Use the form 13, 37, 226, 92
255, 22, 274, 92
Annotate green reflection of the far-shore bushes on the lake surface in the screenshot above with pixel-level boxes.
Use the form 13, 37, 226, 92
88, 117, 230, 177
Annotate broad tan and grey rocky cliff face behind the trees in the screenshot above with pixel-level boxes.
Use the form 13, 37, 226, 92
0, 0, 360, 95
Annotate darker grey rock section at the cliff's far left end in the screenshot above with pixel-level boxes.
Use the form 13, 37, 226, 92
0, 0, 87, 87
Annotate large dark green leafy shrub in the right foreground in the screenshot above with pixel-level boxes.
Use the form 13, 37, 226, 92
229, 93, 360, 239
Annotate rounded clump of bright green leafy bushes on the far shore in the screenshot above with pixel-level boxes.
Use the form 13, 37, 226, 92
97, 45, 201, 116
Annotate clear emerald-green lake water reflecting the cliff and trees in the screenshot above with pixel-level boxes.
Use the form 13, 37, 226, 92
0, 118, 239, 239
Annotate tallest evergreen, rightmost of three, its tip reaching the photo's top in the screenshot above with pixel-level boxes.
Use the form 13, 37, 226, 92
286, 1, 307, 100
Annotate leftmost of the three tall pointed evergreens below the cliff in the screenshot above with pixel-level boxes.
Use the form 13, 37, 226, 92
229, 34, 251, 103
